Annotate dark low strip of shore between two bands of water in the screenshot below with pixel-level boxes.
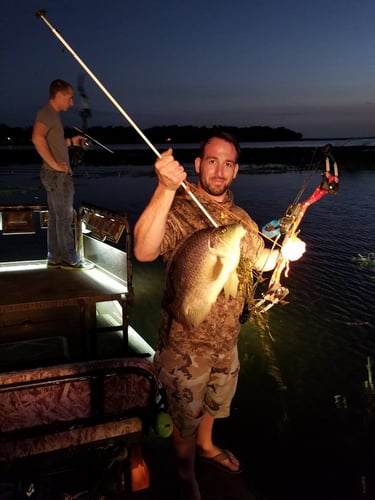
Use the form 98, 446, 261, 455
0, 144, 375, 169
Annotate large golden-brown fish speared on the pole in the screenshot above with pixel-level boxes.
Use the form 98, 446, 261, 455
165, 224, 246, 329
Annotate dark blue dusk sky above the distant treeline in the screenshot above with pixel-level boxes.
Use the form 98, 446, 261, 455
0, 0, 375, 138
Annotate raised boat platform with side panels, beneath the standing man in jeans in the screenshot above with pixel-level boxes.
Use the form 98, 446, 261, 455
0, 204, 144, 369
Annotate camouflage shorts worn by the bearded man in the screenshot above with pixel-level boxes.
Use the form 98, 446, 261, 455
154, 346, 239, 437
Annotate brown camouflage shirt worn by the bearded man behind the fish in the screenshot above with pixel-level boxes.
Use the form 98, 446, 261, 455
159, 186, 264, 354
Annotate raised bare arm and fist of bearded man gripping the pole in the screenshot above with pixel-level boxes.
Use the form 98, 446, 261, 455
134, 149, 186, 262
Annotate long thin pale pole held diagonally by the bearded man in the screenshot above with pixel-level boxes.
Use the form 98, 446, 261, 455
35, 10, 218, 227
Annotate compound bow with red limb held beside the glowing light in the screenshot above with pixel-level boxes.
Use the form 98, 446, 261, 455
254, 145, 339, 313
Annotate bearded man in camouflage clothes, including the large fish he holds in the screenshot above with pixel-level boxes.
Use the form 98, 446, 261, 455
134, 132, 303, 500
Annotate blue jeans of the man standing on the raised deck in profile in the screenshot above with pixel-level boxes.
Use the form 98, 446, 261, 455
40, 167, 79, 264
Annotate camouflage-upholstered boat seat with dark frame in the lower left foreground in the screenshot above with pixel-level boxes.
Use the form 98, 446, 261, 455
0, 358, 159, 490
